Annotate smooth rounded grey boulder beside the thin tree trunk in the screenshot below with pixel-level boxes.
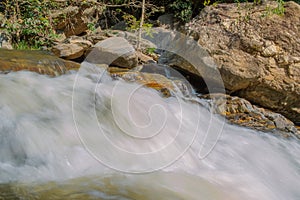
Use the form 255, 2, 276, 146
86, 37, 138, 68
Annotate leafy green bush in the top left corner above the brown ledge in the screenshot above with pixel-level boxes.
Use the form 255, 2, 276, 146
3, 0, 56, 48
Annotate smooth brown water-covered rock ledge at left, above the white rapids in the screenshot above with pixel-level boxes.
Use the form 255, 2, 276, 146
0, 49, 80, 76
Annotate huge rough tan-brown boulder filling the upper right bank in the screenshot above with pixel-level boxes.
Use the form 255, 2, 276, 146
170, 2, 300, 122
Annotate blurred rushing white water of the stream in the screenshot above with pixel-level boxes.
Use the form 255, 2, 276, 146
0, 68, 300, 200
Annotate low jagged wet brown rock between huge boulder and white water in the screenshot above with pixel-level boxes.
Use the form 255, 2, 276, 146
201, 93, 300, 139
